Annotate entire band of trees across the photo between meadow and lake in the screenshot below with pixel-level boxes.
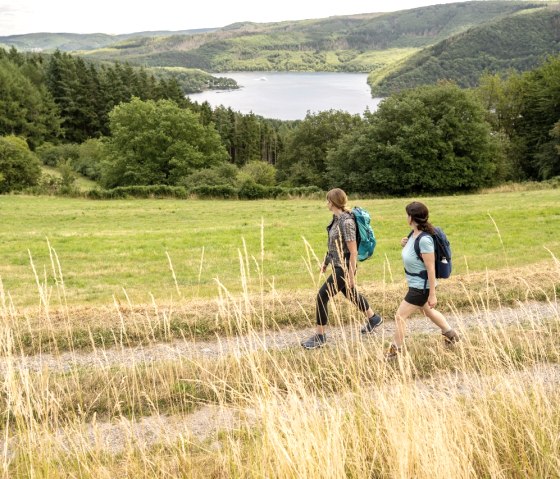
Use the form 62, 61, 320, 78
0, 46, 560, 197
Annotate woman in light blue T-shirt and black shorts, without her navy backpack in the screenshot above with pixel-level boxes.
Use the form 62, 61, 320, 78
386, 201, 459, 359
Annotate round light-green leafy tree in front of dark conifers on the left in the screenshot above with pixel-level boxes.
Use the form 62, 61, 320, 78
102, 98, 227, 187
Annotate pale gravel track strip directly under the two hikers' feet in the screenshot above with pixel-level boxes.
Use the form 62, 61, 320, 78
0, 303, 560, 372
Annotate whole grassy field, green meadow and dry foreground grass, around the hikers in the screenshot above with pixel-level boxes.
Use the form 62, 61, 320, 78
0, 190, 560, 479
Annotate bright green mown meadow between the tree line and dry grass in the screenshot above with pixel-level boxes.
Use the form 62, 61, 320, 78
0, 190, 560, 306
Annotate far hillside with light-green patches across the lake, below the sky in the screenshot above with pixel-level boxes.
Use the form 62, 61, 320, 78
74, 1, 542, 73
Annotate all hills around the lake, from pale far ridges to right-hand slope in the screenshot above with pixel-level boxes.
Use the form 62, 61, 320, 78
0, 0, 560, 96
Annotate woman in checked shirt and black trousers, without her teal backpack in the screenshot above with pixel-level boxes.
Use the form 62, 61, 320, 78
301, 188, 383, 349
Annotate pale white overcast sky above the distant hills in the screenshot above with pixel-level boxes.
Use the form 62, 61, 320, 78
0, 0, 472, 36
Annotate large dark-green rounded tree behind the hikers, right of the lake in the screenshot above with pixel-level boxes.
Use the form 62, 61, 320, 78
327, 84, 498, 194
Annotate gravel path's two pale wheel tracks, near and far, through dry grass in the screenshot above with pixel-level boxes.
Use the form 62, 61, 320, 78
0, 303, 560, 458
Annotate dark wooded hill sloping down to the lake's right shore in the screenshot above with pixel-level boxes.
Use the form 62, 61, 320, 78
370, 6, 560, 96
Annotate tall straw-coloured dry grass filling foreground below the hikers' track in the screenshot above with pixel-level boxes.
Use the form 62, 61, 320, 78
0, 238, 560, 478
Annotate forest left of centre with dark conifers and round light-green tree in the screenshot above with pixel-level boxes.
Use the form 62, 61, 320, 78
0, 48, 291, 196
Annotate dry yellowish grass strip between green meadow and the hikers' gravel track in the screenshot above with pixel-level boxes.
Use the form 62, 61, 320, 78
0, 237, 560, 355
